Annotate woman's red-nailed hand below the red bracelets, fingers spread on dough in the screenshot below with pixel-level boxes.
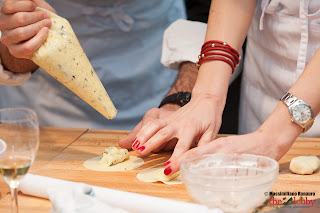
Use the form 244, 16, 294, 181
125, 94, 224, 158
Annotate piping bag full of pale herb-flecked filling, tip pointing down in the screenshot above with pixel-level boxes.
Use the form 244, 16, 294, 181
31, 8, 117, 119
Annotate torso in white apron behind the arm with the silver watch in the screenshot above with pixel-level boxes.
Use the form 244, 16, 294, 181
239, 0, 320, 137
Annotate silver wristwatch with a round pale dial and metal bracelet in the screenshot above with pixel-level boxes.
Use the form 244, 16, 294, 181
280, 92, 314, 133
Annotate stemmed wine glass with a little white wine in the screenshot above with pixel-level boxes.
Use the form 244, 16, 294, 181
0, 108, 39, 212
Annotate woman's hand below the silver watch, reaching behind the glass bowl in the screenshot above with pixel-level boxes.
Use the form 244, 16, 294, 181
165, 102, 302, 175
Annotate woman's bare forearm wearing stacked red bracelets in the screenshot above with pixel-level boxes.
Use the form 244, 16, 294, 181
193, 0, 255, 99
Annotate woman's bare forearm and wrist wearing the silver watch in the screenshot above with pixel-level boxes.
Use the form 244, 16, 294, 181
258, 49, 320, 156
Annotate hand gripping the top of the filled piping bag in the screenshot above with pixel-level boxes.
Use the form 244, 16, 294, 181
0, 0, 55, 59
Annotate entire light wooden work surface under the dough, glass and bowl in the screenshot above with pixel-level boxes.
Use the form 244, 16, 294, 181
0, 128, 320, 212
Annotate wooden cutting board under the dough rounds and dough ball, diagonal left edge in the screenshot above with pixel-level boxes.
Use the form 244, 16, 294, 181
30, 130, 320, 202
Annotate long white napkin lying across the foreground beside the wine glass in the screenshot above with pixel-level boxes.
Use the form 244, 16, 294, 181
19, 174, 223, 213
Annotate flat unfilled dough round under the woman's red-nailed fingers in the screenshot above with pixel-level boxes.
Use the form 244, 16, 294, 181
137, 167, 182, 184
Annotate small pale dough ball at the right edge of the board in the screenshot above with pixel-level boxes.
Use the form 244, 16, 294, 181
290, 156, 320, 175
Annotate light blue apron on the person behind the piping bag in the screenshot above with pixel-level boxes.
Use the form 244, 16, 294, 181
0, 0, 185, 129
